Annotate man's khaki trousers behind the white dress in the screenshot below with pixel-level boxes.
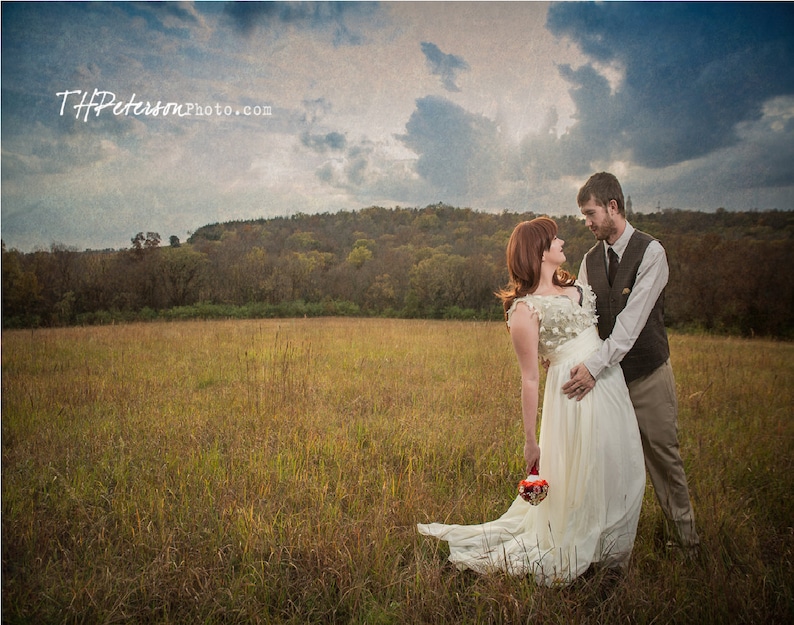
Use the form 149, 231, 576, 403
628, 360, 700, 546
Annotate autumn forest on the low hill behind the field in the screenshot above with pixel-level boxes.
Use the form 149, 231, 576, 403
2, 204, 794, 339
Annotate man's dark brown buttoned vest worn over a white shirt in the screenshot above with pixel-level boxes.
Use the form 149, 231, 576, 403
585, 230, 670, 382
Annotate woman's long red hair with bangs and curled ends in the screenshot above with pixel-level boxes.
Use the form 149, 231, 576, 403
496, 217, 574, 317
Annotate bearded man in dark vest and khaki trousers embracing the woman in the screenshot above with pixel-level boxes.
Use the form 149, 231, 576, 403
562, 172, 700, 547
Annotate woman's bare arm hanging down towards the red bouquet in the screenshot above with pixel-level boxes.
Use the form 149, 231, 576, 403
510, 305, 540, 475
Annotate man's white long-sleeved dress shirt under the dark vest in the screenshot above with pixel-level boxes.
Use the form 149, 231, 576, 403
579, 222, 670, 378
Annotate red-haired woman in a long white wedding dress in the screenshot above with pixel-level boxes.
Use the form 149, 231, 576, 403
417, 217, 645, 586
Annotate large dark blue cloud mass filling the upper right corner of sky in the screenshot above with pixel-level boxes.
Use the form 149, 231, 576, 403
547, 2, 794, 167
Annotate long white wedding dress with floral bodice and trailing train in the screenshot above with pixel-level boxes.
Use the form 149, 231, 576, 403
417, 283, 645, 585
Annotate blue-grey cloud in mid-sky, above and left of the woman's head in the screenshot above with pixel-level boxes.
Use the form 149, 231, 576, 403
399, 96, 500, 199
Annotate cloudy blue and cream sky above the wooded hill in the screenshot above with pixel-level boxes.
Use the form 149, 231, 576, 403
0, 2, 794, 251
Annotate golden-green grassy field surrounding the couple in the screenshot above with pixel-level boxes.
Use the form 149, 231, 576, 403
2, 319, 794, 624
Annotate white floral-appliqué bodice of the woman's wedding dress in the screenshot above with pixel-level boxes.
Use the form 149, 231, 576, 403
507, 282, 598, 358
